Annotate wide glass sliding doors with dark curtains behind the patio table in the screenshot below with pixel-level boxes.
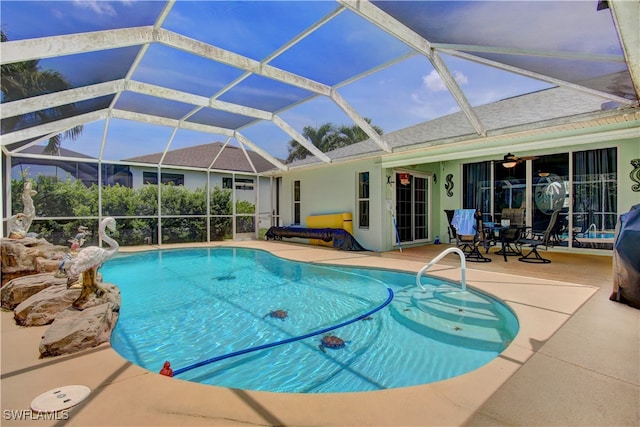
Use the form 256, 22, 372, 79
462, 147, 618, 250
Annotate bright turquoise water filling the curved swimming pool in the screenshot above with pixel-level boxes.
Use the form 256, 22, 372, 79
101, 248, 518, 393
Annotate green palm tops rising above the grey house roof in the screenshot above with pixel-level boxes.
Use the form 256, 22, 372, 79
287, 118, 383, 163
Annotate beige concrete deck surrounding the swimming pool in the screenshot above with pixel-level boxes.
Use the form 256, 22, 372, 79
1, 241, 640, 426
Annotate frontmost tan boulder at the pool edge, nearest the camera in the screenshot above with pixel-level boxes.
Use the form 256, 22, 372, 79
40, 302, 118, 357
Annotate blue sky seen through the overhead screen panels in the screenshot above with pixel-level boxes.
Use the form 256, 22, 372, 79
0, 0, 617, 160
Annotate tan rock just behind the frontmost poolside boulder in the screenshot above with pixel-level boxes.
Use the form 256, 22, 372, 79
13, 284, 80, 326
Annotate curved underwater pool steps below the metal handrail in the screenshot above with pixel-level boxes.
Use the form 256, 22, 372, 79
390, 287, 517, 351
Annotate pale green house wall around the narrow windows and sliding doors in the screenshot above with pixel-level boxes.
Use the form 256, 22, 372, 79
281, 128, 640, 251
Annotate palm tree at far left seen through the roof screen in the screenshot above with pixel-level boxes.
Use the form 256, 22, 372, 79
0, 32, 82, 155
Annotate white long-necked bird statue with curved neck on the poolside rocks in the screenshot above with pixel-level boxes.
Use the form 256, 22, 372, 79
69, 217, 120, 307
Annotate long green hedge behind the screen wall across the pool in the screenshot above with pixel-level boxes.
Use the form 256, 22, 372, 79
11, 175, 255, 246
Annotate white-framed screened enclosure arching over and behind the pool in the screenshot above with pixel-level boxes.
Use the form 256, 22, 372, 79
0, 0, 640, 245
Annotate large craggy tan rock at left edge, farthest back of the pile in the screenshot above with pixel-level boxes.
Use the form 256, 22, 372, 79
1, 237, 69, 285
